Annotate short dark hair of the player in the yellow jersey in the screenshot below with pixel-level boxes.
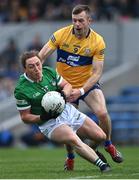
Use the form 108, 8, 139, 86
72, 4, 91, 17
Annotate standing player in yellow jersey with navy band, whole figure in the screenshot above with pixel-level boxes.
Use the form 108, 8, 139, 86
38, 4, 123, 166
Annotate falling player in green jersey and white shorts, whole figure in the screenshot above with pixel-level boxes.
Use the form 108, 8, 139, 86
14, 51, 110, 172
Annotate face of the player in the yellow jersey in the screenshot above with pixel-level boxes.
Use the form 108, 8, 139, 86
72, 11, 91, 38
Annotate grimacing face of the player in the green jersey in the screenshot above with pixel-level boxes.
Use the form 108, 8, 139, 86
25, 56, 42, 82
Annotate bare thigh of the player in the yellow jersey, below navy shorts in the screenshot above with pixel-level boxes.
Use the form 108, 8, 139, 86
84, 89, 107, 114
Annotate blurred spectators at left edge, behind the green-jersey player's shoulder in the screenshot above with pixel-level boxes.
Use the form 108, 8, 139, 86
0, 39, 19, 100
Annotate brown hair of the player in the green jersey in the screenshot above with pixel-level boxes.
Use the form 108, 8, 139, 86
20, 50, 40, 68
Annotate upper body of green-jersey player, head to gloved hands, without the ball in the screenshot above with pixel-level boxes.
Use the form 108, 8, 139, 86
14, 51, 72, 124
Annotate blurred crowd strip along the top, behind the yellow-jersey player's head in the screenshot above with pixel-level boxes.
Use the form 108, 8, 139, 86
0, 0, 139, 23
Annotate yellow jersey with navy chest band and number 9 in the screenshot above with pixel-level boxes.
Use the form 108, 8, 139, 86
48, 25, 105, 88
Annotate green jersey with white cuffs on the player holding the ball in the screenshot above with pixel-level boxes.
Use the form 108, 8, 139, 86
14, 66, 62, 115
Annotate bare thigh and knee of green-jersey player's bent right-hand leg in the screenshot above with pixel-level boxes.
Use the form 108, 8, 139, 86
77, 117, 106, 141
